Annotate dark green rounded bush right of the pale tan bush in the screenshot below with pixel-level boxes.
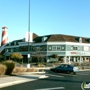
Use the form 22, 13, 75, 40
2, 60, 15, 75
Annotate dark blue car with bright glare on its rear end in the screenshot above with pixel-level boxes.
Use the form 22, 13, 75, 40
50, 64, 79, 74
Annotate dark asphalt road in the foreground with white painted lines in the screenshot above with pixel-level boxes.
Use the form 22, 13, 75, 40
0, 71, 90, 90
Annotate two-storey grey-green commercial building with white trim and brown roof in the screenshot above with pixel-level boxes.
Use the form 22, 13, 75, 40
0, 26, 90, 63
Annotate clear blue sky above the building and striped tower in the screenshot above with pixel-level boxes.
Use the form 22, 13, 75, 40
0, 0, 90, 41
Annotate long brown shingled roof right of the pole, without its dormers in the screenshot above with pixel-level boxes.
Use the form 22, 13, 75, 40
34, 34, 90, 43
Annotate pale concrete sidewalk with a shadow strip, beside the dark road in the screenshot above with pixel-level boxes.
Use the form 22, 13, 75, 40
0, 73, 48, 88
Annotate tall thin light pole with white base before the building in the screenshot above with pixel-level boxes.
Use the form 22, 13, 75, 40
27, 0, 30, 68
